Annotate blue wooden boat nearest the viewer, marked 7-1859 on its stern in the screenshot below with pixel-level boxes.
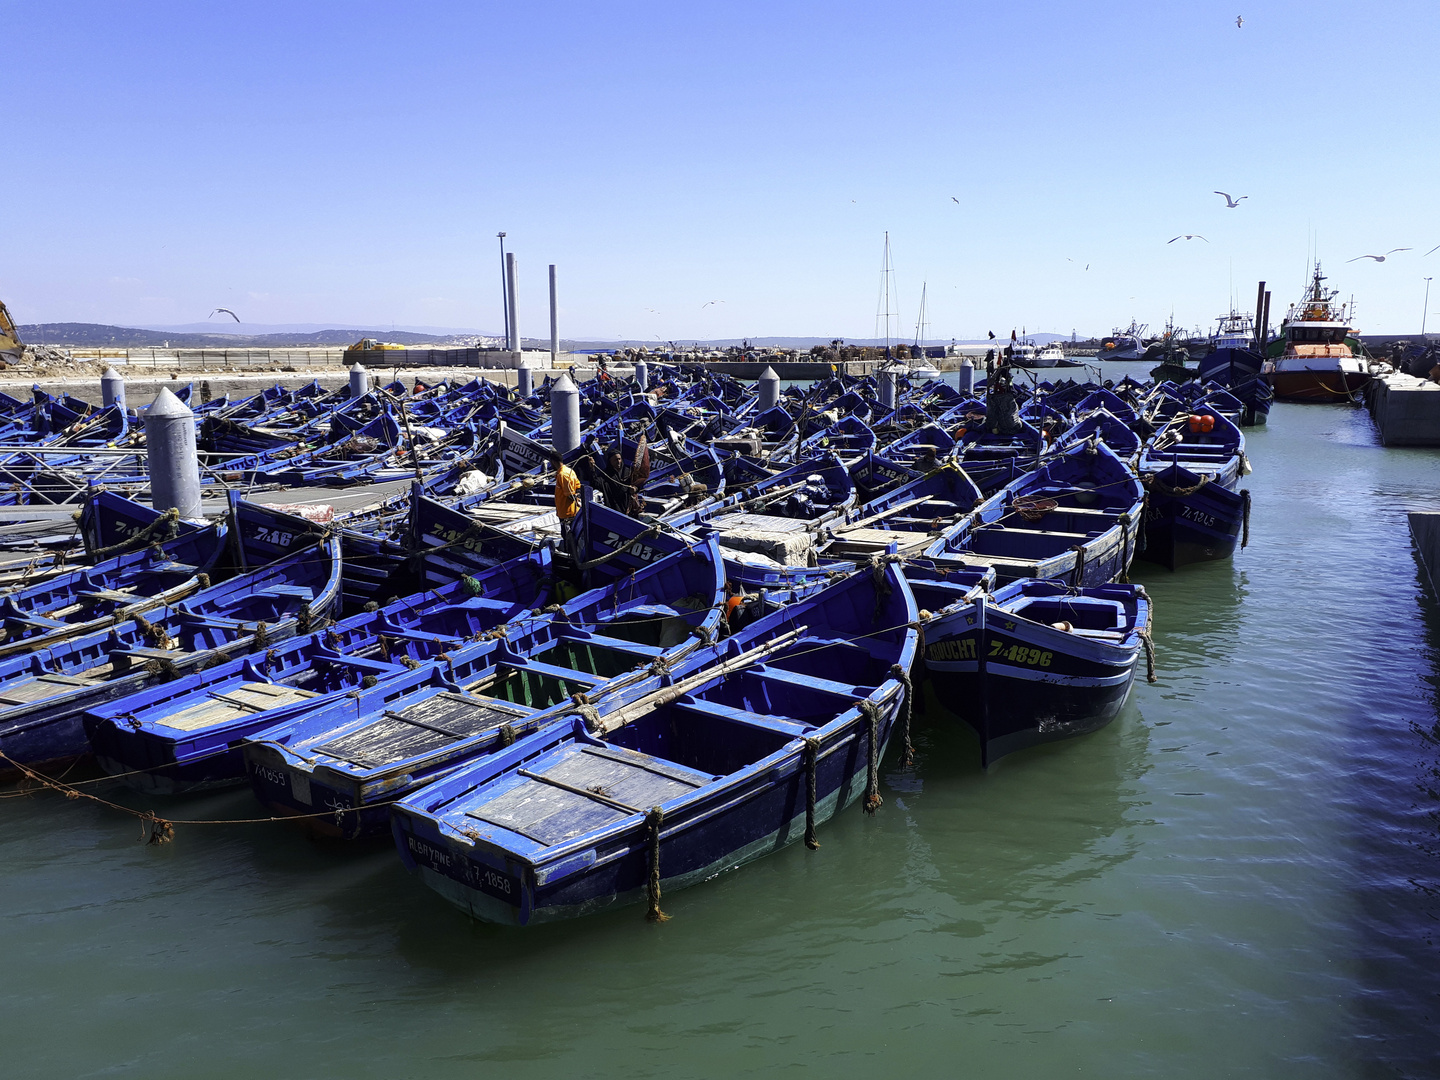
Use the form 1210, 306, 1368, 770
392, 564, 917, 926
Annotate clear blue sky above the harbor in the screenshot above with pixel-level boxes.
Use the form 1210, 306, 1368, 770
0, 0, 1440, 338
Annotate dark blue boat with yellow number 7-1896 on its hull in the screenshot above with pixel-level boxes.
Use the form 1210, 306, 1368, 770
910, 577, 1151, 766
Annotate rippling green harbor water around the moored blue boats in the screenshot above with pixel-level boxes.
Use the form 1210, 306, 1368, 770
0, 391, 1440, 1080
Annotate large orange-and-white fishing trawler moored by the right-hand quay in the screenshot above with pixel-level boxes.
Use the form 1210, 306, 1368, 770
1264, 262, 1371, 402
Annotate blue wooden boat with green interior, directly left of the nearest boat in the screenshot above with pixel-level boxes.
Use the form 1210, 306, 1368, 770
242, 539, 724, 840
